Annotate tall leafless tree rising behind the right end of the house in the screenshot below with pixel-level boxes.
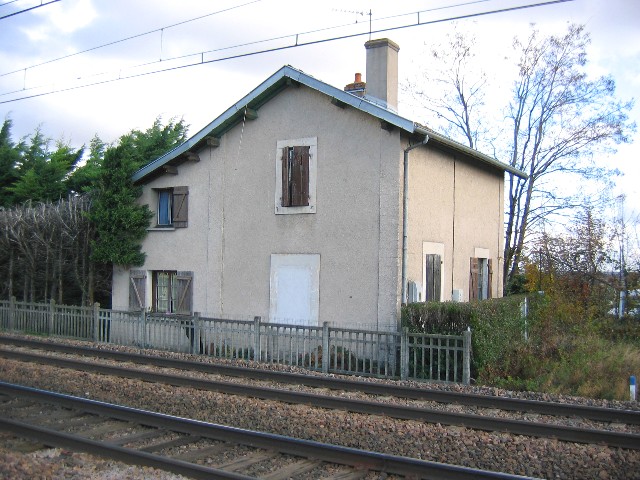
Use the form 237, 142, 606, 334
408, 25, 635, 291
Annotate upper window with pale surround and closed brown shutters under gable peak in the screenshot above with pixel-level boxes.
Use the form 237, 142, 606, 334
275, 137, 317, 214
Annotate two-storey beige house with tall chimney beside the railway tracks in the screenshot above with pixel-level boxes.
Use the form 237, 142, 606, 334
112, 39, 524, 330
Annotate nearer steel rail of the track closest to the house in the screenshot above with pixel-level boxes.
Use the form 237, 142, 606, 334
0, 349, 640, 450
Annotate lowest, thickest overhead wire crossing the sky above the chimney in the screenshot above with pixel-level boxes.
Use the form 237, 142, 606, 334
0, 0, 574, 105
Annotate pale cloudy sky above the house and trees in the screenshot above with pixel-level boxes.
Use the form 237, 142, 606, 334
0, 0, 640, 223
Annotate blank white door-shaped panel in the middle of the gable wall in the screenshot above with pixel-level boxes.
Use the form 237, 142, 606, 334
269, 254, 320, 325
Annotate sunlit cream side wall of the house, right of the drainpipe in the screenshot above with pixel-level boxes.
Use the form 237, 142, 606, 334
407, 144, 504, 301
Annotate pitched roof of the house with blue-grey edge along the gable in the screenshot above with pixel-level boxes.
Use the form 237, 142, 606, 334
133, 65, 526, 182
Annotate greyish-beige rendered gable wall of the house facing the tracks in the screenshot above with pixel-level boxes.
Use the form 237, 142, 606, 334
113, 87, 402, 328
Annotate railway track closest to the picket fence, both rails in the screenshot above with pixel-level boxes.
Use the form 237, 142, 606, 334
0, 337, 640, 450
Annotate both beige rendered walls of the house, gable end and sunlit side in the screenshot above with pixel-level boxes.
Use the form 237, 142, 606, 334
113, 86, 503, 329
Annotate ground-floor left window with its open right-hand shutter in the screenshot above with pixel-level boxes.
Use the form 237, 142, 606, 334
153, 270, 193, 315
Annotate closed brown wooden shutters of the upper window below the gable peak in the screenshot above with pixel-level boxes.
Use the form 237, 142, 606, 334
282, 146, 309, 207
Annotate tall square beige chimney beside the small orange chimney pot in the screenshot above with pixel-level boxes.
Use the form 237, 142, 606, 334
364, 38, 400, 111
